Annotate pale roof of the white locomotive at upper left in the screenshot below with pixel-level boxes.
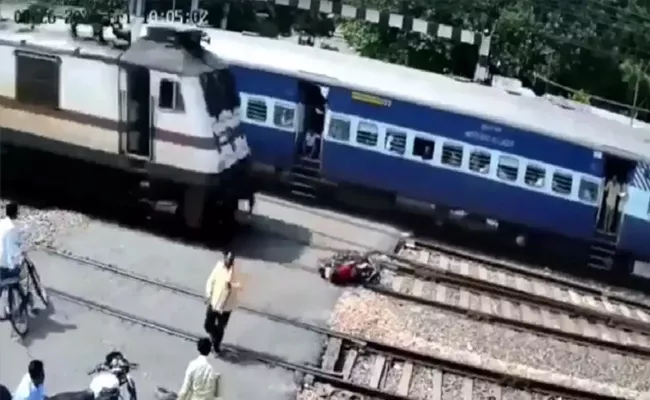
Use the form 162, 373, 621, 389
0, 21, 224, 76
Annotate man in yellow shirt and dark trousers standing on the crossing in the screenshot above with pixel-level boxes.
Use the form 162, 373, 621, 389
203, 252, 241, 354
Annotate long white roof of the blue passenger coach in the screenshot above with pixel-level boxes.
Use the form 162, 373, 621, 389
204, 29, 650, 162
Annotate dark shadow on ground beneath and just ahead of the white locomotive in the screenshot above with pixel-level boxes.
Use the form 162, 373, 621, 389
0, 166, 313, 263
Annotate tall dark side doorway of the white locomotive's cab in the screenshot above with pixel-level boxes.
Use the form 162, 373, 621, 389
119, 66, 153, 160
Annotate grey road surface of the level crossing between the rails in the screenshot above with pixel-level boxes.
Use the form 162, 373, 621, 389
0, 196, 399, 400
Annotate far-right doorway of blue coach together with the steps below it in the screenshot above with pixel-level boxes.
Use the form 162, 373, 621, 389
588, 153, 636, 269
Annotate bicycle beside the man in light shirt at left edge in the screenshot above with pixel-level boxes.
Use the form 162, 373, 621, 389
0, 255, 50, 338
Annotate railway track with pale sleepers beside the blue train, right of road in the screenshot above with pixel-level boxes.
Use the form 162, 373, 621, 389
360, 239, 650, 357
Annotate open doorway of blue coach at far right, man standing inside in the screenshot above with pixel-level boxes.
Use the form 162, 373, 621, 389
596, 154, 636, 237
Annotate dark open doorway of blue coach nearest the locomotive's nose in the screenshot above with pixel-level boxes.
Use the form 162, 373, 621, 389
296, 81, 329, 160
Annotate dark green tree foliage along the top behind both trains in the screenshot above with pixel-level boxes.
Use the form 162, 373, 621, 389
20, 0, 650, 119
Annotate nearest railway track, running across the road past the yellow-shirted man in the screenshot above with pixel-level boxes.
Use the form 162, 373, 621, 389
43, 248, 623, 400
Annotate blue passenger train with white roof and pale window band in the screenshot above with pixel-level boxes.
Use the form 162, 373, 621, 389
205, 29, 650, 284
